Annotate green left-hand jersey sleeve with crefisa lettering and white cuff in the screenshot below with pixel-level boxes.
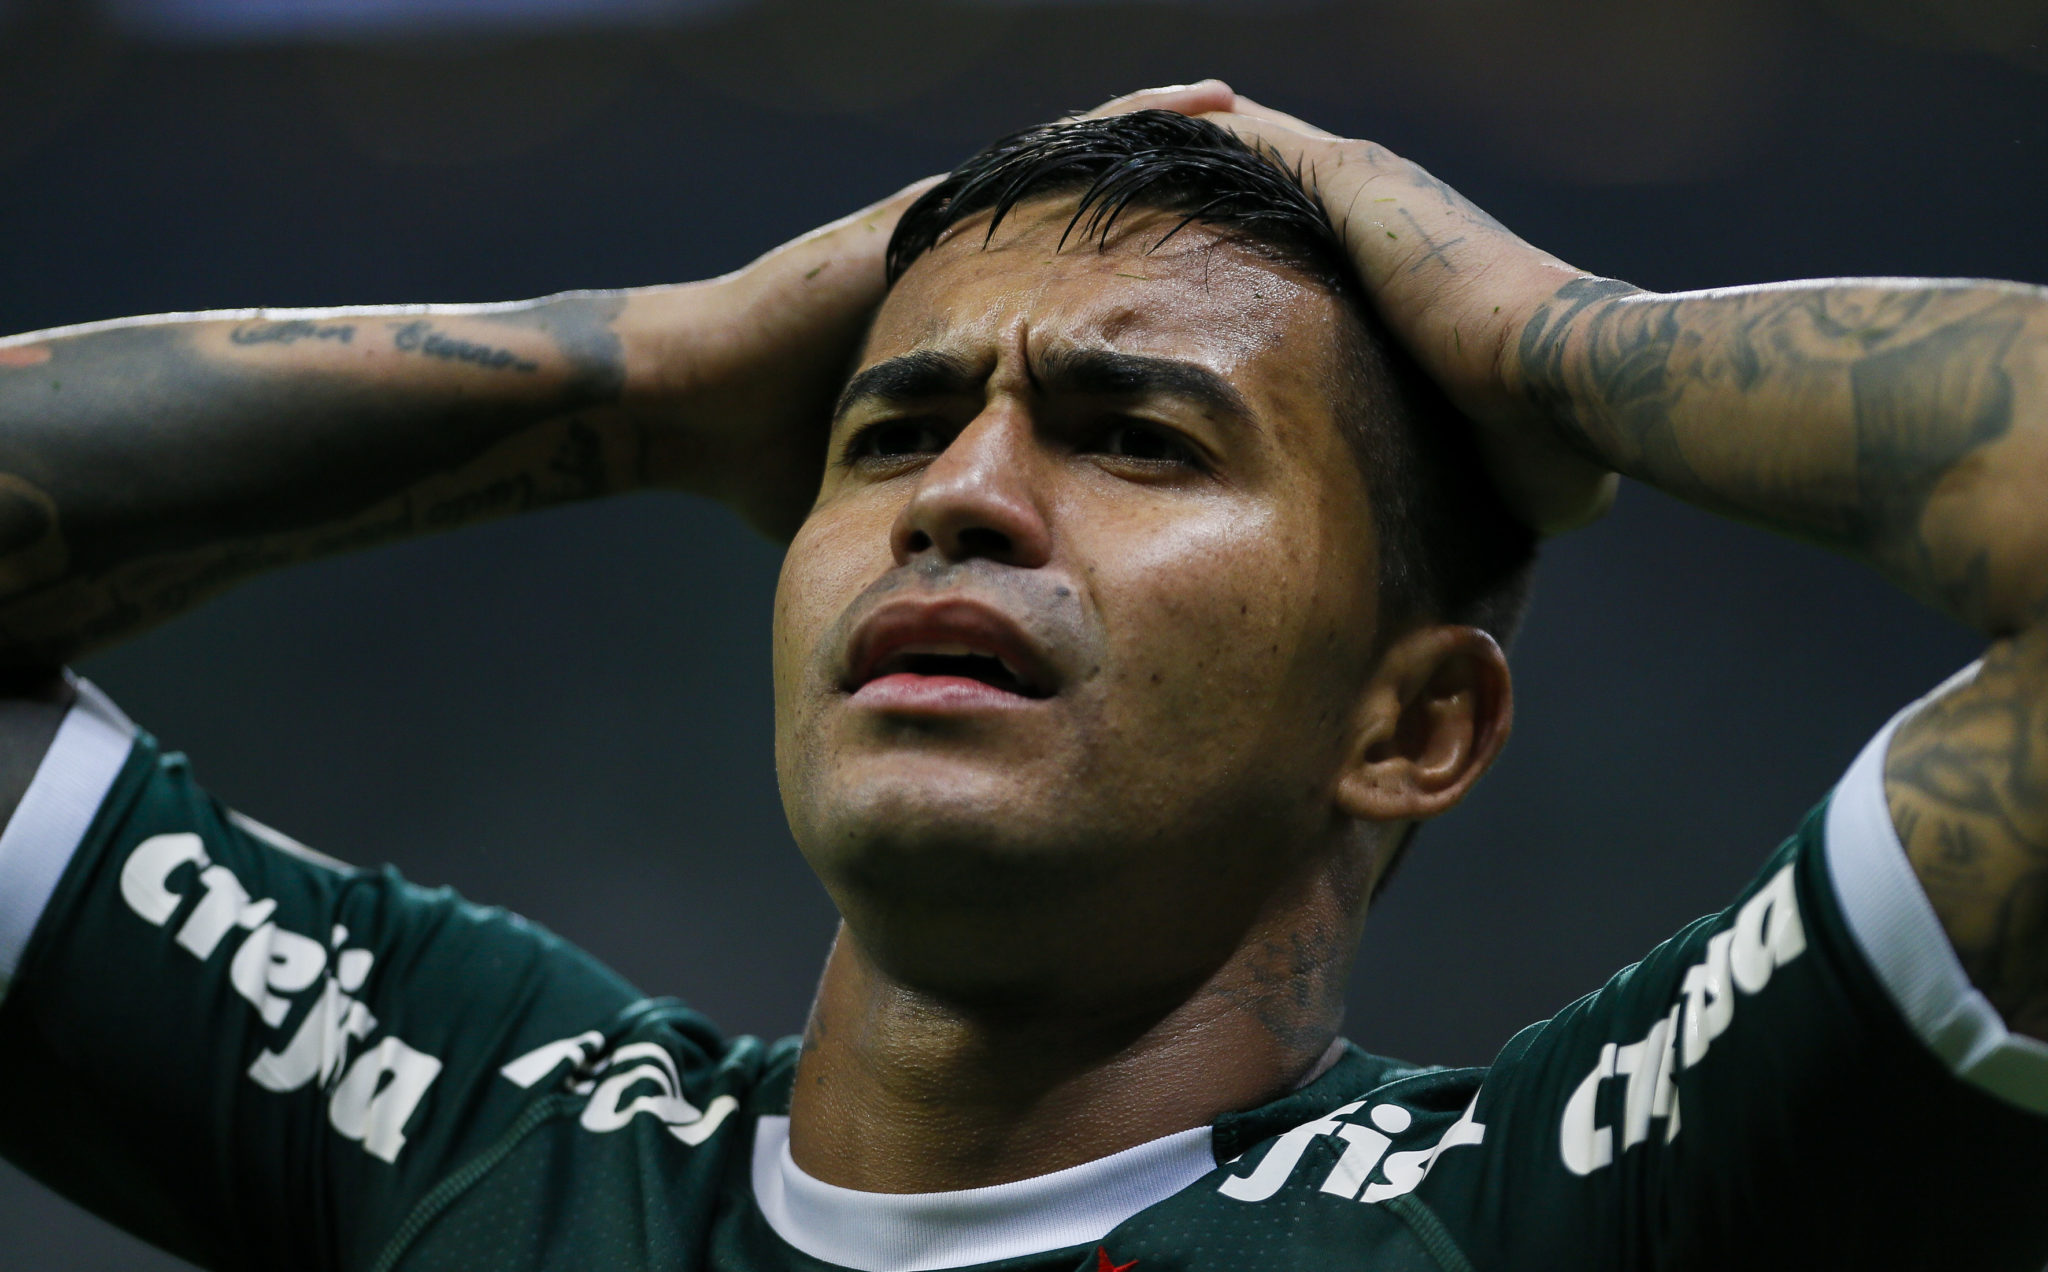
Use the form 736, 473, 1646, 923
0, 686, 639, 1268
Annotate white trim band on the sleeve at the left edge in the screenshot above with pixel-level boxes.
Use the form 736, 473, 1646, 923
0, 680, 135, 998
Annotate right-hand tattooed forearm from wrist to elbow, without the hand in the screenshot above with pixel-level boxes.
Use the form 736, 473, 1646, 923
1507, 279, 2048, 635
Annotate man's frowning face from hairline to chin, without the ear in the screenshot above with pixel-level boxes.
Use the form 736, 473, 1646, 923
774, 201, 1374, 979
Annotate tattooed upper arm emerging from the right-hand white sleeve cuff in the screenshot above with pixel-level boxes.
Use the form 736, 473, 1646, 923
1884, 631, 2048, 1038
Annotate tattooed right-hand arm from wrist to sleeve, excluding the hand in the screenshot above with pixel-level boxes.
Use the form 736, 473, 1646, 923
1518, 279, 2048, 1038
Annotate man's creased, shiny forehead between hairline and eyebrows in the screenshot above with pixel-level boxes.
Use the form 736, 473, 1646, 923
862, 199, 1348, 380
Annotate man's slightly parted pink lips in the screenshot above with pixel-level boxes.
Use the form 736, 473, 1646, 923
842, 596, 1059, 711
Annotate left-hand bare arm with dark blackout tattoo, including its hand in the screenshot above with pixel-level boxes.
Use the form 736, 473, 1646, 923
0, 199, 901, 672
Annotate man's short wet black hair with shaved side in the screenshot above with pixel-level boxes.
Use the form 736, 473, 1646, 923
887, 111, 1536, 647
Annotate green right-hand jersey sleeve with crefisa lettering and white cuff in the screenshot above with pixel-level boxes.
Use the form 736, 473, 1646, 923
1417, 700, 2048, 1272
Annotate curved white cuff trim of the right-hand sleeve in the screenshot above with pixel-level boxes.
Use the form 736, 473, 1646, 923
1825, 666, 2048, 1114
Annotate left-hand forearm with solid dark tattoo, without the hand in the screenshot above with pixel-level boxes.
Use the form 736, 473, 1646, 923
0, 286, 663, 668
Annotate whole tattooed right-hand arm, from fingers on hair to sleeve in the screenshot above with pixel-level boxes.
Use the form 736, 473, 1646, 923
1229, 102, 2048, 1038
